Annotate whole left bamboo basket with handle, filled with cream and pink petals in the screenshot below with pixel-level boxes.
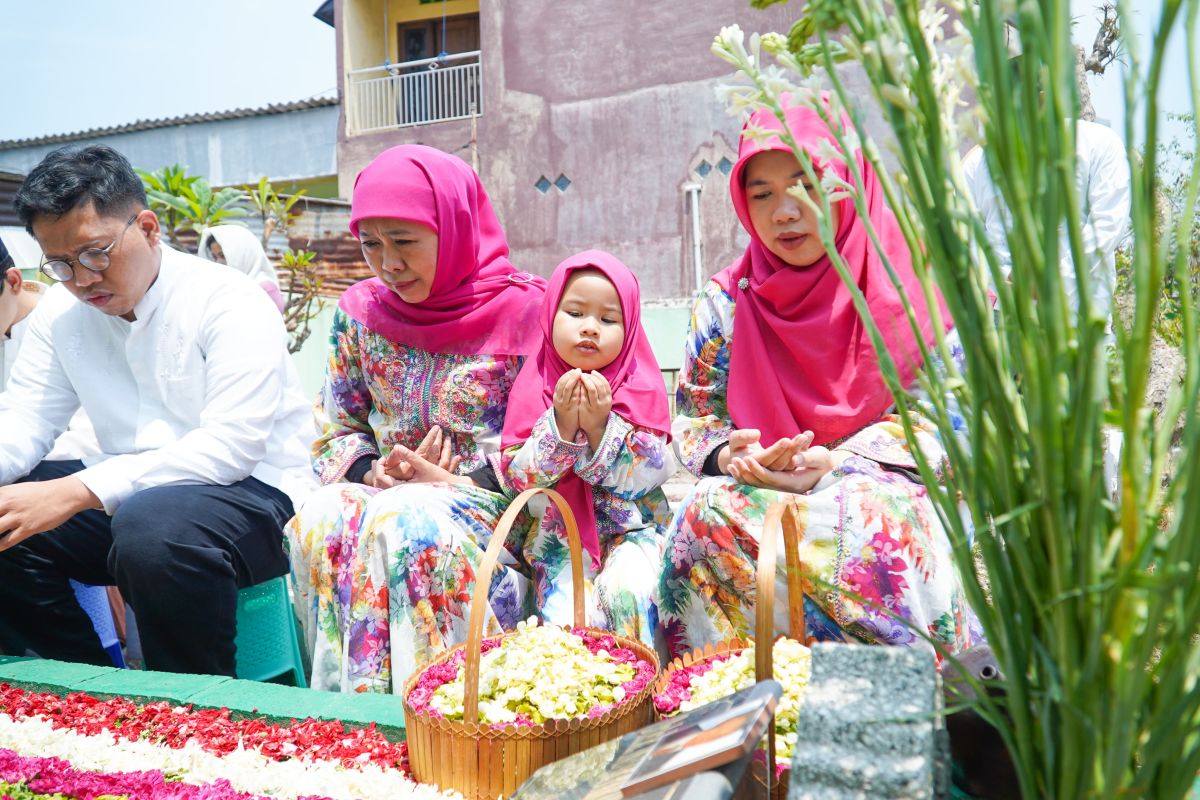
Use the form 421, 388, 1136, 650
404, 488, 659, 800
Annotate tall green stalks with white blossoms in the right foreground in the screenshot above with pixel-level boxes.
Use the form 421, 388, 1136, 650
714, 0, 1200, 798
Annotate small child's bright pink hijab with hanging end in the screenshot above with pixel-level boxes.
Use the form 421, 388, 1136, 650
500, 249, 671, 567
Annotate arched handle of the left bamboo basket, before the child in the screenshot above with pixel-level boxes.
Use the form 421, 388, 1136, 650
462, 487, 587, 723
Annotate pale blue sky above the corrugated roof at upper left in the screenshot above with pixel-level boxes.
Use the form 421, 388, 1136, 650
0, 0, 337, 140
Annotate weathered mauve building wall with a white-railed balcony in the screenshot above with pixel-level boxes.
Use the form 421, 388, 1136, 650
334, 0, 844, 302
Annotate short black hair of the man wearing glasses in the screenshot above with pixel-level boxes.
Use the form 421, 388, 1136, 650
13, 144, 146, 233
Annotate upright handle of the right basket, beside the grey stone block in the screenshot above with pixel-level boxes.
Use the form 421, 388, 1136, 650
754, 501, 805, 680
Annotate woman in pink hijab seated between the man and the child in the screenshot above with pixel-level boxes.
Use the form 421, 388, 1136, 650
287, 145, 546, 692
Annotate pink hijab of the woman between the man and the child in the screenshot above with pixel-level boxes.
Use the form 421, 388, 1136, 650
340, 144, 546, 355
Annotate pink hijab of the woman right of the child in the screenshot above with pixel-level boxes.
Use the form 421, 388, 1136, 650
714, 98, 952, 446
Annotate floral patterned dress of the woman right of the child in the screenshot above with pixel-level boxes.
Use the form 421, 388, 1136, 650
656, 282, 982, 656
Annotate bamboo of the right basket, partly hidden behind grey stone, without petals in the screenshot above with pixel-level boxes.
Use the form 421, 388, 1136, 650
654, 501, 811, 800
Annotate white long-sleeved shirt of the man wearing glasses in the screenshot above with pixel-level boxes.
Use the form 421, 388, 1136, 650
0, 247, 314, 515
